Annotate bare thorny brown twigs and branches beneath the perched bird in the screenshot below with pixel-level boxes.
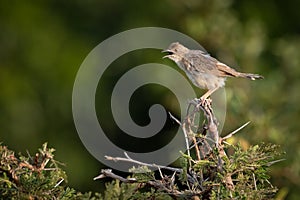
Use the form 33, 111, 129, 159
94, 99, 253, 196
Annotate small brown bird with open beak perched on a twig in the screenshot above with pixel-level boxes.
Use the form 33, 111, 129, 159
163, 42, 263, 100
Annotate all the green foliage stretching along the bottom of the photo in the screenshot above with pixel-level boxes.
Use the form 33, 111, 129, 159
0, 141, 282, 200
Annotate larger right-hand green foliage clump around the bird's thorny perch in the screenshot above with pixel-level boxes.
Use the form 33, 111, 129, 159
98, 144, 283, 199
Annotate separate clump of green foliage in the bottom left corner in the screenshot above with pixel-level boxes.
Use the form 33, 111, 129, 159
0, 143, 100, 200
